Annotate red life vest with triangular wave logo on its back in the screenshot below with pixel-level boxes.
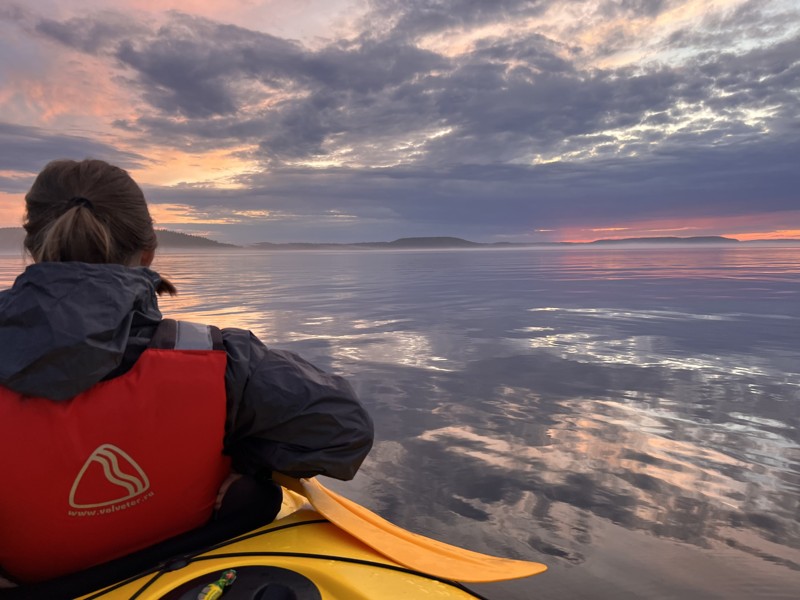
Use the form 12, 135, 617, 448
0, 321, 230, 583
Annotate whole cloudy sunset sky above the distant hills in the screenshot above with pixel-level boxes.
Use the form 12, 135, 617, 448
0, 0, 800, 243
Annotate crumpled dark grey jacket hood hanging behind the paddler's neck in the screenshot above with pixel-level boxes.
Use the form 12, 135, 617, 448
0, 262, 161, 400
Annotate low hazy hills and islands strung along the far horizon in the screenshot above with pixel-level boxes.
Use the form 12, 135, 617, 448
0, 227, 800, 254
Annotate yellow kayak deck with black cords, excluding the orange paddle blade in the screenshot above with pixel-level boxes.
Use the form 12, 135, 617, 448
81, 490, 496, 600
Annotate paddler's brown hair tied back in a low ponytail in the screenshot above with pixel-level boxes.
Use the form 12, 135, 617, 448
23, 159, 176, 295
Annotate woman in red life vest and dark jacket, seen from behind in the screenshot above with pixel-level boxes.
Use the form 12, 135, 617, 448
0, 159, 373, 584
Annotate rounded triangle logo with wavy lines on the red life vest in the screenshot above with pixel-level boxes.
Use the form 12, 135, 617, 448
69, 444, 150, 508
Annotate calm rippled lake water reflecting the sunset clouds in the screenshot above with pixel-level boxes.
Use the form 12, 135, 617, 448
0, 246, 800, 600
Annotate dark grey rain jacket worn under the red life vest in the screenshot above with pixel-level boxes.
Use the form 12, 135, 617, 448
0, 262, 373, 479
